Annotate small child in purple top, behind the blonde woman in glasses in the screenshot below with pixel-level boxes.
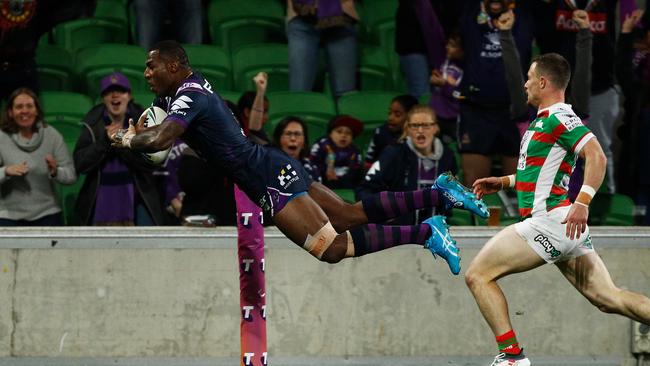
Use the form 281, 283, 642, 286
429, 33, 463, 143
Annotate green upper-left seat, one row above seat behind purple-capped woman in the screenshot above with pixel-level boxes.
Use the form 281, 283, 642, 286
54, 19, 126, 51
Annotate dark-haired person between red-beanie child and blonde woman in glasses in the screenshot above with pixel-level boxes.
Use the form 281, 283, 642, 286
364, 94, 418, 170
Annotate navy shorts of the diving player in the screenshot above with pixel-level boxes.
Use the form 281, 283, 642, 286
252, 148, 312, 216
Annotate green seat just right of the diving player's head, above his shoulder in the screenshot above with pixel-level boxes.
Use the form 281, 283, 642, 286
183, 44, 232, 90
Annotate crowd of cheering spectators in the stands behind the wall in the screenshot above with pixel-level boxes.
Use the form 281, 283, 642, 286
0, 0, 650, 225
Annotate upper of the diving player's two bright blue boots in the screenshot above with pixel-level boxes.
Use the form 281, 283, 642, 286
432, 173, 490, 219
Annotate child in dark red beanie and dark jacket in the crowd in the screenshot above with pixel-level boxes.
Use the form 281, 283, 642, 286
309, 115, 363, 189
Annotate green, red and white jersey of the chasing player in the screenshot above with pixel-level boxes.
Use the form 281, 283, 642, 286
515, 103, 594, 217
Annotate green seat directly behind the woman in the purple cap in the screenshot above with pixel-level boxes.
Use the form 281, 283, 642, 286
76, 44, 149, 97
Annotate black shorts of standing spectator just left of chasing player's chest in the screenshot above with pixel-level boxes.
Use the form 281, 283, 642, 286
457, 103, 521, 156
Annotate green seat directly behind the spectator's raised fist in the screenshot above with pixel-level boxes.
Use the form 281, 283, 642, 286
232, 43, 289, 92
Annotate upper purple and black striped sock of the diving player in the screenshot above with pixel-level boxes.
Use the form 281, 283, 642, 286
361, 188, 438, 222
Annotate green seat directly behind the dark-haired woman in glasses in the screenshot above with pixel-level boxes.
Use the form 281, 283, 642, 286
264, 91, 336, 145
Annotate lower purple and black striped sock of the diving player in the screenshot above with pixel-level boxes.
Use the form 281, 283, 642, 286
350, 224, 431, 257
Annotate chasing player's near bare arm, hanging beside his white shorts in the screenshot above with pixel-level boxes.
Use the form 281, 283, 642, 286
562, 138, 607, 239
